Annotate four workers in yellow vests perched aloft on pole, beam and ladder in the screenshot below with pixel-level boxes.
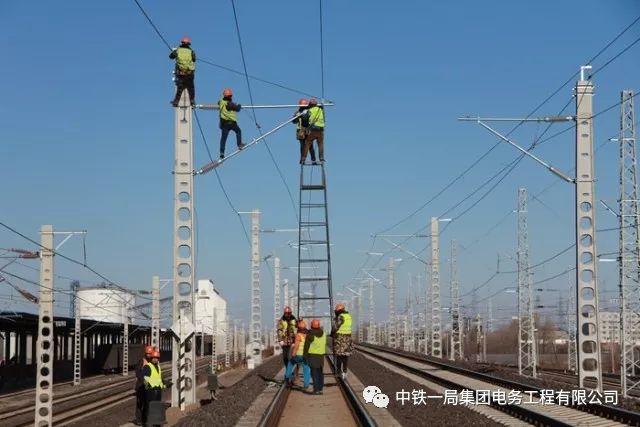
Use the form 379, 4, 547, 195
169, 37, 324, 165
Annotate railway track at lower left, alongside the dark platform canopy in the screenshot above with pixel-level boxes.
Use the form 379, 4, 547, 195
0, 359, 209, 427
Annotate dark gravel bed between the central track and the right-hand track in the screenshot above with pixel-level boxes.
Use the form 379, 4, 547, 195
349, 352, 501, 427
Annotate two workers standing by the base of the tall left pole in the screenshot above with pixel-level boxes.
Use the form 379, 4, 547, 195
134, 345, 166, 426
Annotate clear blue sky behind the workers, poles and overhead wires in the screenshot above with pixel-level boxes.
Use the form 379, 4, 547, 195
0, 0, 640, 330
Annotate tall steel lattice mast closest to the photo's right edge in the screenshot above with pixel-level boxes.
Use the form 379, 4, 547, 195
618, 90, 640, 397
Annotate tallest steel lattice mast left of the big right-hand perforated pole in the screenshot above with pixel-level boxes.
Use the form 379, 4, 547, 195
518, 188, 537, 378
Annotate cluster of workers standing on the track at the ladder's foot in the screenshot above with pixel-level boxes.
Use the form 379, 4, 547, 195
278, 304, 353, 394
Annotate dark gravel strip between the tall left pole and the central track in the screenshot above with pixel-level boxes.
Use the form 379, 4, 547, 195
176, 357, 282, 427
